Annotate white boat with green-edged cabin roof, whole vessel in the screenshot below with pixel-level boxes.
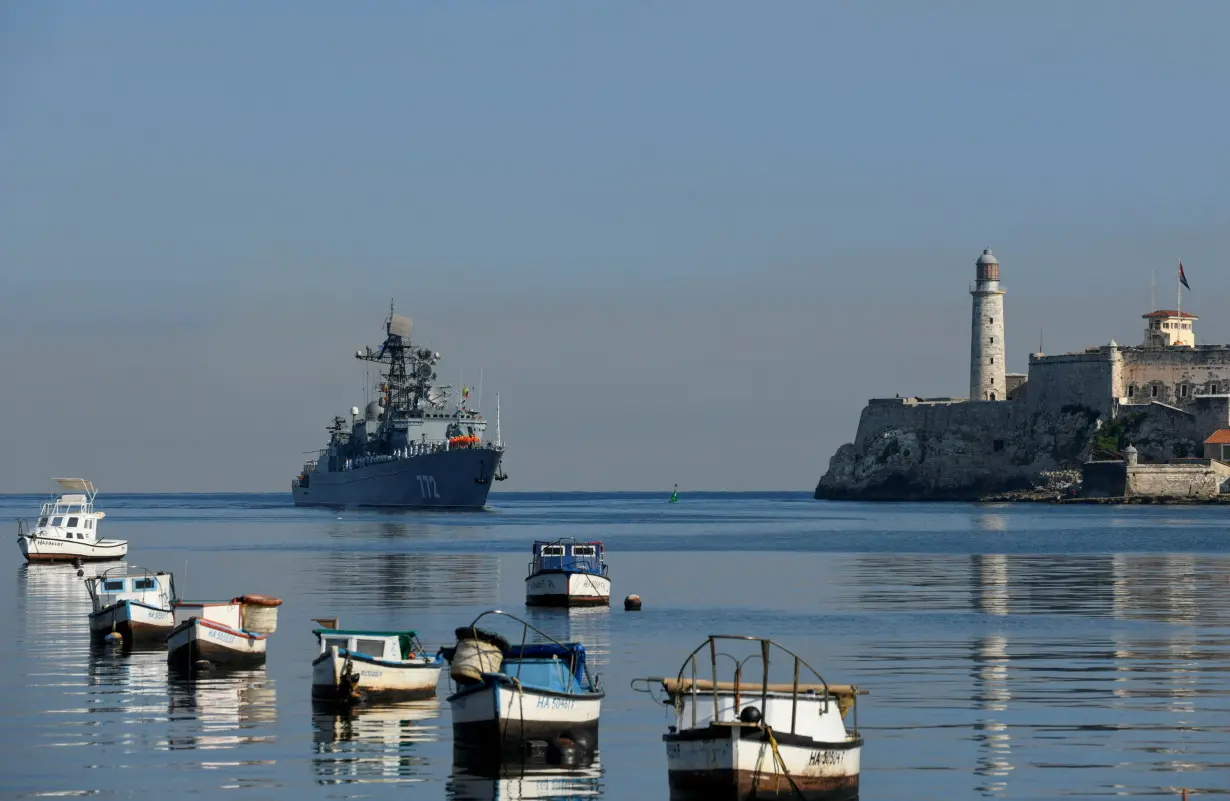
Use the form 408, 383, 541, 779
311, 620, 444, 701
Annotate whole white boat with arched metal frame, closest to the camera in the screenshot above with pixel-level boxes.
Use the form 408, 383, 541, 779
632, 635, 867, 801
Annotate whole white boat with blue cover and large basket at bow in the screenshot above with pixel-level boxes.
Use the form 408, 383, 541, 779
442, 609, 605, 754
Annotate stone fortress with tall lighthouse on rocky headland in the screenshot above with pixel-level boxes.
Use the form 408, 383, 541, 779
815, 250, 1230, 500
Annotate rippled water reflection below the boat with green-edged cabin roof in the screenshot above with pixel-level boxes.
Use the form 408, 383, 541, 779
311, 698, 440, 784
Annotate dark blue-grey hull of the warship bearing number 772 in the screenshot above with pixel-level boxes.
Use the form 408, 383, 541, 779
292, 448, 503, 509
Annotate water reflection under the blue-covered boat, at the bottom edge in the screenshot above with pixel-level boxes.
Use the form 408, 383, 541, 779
448, 749, 603, 801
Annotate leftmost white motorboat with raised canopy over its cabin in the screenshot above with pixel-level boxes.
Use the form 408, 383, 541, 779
17, 479, 128, 562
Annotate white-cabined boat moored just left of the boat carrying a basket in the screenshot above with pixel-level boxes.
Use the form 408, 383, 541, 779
85, 565, 176, 645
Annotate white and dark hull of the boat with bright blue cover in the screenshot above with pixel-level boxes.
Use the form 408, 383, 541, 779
449, 675, 604, 751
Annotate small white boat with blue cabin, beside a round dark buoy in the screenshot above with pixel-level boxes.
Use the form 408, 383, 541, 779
525, 536, 611, 607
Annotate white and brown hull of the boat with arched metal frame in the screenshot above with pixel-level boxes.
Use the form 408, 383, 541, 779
663, 725, 862, 801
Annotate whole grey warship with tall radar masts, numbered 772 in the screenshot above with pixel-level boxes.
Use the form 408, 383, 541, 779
290, 305, 508, 509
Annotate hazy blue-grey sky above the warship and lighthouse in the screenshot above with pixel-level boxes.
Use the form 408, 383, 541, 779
0, 0, 1230, 492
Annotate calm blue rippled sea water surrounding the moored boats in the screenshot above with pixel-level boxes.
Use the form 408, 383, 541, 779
0, 493, 1230, 801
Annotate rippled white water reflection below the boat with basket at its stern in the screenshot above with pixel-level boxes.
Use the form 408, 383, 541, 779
167, 668, 278, 751
